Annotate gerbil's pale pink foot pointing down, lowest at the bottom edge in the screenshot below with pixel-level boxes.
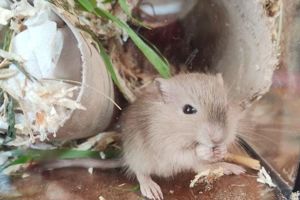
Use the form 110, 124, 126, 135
137, 175, 163, 200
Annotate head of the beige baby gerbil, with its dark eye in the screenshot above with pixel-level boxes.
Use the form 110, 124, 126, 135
153, 73, 237, 146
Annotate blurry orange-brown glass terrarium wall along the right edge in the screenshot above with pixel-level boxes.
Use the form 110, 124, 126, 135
244, 1, 300, 189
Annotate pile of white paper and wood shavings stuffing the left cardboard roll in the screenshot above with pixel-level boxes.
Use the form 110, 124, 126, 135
0, 0, 85, 146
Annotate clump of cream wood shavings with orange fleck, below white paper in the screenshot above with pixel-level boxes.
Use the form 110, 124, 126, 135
0, 79, 84, 141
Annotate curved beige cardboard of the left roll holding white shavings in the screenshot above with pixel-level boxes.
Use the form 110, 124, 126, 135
52, 7, 114, 140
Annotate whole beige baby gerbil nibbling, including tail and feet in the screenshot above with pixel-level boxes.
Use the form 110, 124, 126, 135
45, 73, 244, 199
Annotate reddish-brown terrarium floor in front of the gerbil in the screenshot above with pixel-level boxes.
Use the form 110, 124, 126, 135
9, 168, 278, 200
